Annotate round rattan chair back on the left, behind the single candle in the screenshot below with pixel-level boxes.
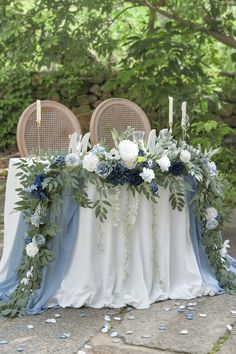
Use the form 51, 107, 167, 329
17, 100, 81, 156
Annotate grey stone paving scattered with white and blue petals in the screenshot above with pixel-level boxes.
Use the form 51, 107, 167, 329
0, 182, 236, 354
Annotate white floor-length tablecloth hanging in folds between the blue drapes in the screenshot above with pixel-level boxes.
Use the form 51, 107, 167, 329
0, 159, 214, 308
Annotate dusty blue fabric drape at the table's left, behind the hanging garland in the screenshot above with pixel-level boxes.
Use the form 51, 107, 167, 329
0, 196, 79, 315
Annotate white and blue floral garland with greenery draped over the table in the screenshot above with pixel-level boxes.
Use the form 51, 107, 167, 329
0, 129, 236, 317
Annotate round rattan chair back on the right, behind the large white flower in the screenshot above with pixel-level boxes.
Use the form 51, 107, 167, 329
90, 98, 151, 147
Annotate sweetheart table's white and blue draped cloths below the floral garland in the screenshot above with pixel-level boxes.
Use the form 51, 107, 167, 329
0, 159, 222, 314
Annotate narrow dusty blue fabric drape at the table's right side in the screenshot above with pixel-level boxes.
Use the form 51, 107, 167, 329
185, 176, 223, 293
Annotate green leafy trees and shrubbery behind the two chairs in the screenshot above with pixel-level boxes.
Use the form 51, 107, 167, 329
0, 0, 236, 206
